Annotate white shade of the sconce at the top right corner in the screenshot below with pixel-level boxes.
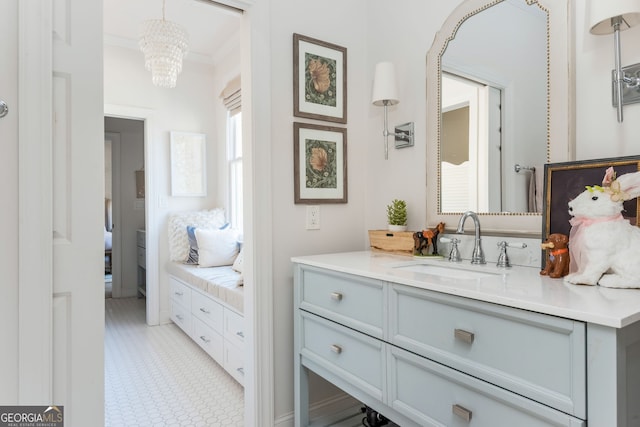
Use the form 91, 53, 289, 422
589, 0, 640, 35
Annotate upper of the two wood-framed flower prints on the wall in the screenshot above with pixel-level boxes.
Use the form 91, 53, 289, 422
293, 33, 347, 123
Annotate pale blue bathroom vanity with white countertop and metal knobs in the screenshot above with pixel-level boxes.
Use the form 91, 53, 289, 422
292, 251, 640, 427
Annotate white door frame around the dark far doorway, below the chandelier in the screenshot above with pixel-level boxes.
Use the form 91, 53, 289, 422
104, 104, 160, 326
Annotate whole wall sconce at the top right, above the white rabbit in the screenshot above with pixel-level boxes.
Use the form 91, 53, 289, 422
589, 0, 640, 123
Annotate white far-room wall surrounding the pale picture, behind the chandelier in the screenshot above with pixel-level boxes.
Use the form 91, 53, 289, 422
104, 46, 232, 322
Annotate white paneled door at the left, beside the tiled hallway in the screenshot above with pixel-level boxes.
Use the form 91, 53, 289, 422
51, 0, 104, 426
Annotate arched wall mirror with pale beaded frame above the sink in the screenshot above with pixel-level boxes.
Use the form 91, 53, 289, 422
427, 0, 574, 235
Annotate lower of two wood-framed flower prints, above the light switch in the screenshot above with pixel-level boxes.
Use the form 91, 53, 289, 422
293, 122, 348, 204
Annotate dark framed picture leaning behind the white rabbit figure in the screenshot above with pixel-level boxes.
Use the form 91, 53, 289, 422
542, 156, 640, 240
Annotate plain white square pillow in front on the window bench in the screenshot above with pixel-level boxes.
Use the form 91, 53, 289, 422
196, 228, 238, 267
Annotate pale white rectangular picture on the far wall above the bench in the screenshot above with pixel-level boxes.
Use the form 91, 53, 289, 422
170, 131, 207, 197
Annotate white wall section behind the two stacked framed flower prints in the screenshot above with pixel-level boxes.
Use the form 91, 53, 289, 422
266, 0, 371, 417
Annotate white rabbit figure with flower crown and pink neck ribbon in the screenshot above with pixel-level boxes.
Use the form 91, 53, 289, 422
564, 168, 640, 288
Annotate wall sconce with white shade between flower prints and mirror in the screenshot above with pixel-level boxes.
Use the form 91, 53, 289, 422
371, 62, 414, 160
